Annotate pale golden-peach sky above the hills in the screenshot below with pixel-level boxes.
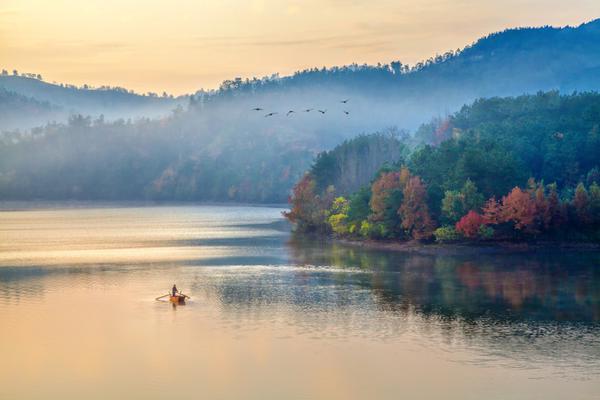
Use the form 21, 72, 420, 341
0, 0, 600, 94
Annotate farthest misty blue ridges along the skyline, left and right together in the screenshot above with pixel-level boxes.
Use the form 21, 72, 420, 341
0, 19, 600, 137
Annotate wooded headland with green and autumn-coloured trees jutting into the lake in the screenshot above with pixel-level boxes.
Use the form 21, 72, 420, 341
286, 92, 600, 242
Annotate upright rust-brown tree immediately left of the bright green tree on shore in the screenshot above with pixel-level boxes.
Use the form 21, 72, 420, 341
398, 176, 434, 240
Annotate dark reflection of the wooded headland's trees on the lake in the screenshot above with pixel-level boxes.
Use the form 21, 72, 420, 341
290, 240, 600, 322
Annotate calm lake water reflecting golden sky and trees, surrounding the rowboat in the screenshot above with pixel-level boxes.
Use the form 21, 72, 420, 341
0, 204, 600, 399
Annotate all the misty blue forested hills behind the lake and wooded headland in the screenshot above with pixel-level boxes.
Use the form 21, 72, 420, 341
0, 20, 600, 202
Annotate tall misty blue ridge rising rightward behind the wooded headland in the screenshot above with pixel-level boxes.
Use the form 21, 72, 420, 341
190, 20, 600, 137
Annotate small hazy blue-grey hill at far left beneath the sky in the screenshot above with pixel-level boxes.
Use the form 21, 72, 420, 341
0, 71, 188, 131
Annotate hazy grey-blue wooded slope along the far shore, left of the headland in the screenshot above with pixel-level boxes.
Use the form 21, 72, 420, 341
0, 114, 314, 202
